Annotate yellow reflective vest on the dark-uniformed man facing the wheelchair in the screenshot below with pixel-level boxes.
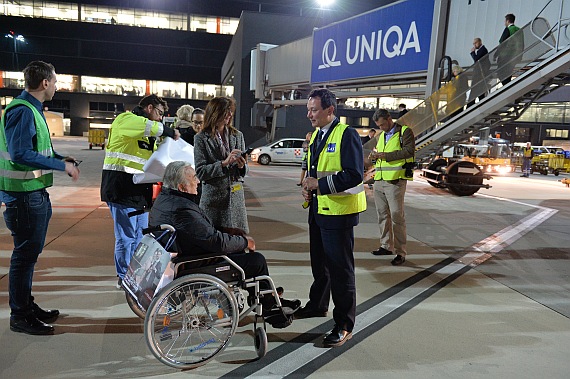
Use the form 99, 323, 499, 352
307, 124, 366, 216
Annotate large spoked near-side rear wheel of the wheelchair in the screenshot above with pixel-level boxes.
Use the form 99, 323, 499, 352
144, 274, 239, 369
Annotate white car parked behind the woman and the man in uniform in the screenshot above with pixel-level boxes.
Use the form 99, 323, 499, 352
250, 138, 305, 165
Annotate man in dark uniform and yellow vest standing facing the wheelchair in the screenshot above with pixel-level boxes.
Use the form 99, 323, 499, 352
295, 89, 366, 347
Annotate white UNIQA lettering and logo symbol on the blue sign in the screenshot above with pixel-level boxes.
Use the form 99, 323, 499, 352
318, 21, 421, 70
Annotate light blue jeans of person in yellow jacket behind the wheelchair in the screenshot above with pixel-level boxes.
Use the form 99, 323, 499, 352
107, 202, 148, 279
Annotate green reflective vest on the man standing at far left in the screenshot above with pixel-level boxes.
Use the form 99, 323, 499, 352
0, 99, 54, 192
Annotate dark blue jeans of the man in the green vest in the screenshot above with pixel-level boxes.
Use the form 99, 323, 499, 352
4, 189, 51, 318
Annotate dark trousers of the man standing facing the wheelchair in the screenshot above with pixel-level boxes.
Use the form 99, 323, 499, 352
307, 221, 356, 332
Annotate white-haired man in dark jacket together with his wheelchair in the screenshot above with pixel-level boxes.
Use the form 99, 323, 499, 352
123, 161, 301, 368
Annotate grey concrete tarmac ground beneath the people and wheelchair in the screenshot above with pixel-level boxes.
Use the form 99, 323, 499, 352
0, 137, 570, 379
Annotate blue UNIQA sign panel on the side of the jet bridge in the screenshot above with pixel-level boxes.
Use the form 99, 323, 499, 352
311, 0, 434, 83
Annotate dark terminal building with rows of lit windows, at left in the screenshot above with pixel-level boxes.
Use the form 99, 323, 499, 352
0, 0, 387, 135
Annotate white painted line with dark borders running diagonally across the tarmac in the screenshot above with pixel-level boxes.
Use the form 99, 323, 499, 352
222, 197, 557, 378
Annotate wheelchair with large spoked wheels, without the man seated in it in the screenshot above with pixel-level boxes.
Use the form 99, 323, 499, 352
123, 225, 292, 369
